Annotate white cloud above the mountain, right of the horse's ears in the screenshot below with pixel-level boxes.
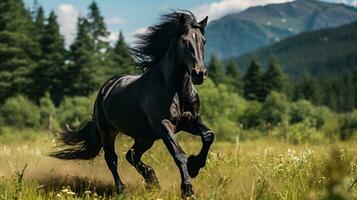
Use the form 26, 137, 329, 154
193, 0, 292, 21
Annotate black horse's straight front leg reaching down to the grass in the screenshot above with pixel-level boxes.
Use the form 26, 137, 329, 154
159, 119, 194, 198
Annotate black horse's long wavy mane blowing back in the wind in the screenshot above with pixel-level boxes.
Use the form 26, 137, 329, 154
130, 10, 197, 72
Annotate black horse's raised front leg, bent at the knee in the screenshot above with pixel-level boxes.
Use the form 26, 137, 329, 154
179, 112, 214, 178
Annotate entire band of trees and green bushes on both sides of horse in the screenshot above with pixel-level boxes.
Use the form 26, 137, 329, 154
0, 0, 357, 143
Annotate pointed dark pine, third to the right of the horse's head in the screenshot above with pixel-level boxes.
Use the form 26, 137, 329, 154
243, 58, 264, 101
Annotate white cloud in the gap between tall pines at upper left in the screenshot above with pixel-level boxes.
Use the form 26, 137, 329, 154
57, 4, 79, 45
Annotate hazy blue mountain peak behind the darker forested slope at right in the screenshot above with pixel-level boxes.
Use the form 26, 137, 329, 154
206, 0, 357, 58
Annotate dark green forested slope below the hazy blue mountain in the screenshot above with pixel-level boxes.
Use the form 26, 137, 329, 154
234, 22, 357, 77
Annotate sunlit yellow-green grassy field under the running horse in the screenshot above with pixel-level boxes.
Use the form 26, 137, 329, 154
0, 131, 357, 200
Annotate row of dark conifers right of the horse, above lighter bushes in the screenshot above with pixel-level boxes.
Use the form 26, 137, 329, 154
208, 54, 357, 112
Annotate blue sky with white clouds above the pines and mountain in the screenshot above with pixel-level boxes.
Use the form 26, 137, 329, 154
24, 0, 357, 44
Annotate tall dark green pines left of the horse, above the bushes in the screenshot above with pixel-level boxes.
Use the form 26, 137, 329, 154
0, 0, 135, 105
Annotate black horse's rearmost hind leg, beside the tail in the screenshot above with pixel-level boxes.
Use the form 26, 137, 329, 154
103, 132, 125, 193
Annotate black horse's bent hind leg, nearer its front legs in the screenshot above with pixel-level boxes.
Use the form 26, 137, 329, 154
126, 140, 160, 189
